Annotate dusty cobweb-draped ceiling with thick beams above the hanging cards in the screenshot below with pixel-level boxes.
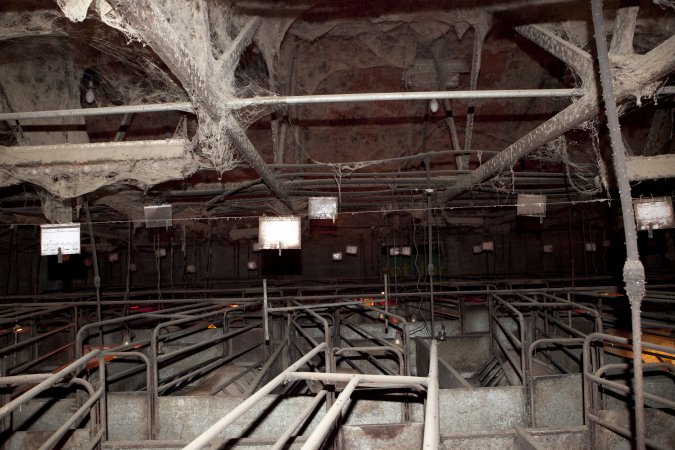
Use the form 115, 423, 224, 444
0, 0, 675, 236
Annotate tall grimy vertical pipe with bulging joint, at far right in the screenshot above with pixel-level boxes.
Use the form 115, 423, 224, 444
591, 0, 645, 450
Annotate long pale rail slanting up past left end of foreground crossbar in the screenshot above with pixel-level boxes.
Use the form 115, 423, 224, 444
183, 342, 326, 450
